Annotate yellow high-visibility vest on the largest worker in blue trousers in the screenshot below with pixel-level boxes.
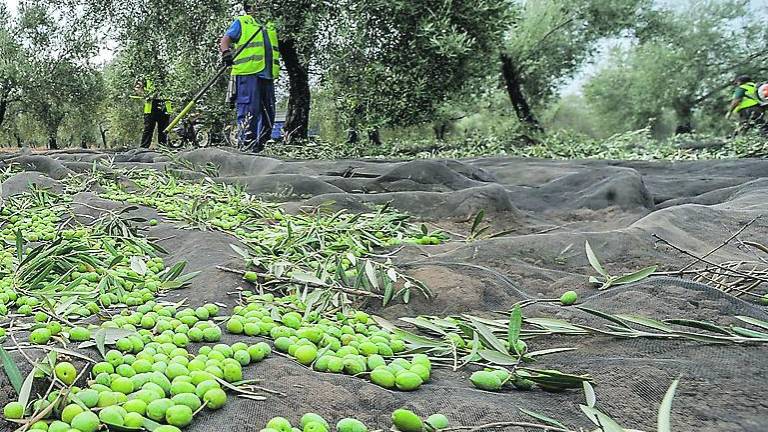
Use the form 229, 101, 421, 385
232, 15, 280, 79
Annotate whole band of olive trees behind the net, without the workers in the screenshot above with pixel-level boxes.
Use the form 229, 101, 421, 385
0, 0, 768, 153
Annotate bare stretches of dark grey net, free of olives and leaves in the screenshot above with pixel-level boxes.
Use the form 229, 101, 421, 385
0, 149, 768, 432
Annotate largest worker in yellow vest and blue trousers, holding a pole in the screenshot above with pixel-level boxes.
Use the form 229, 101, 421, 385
219, 0, 280, 153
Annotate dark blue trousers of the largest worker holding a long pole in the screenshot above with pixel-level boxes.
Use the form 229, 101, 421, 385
235, 75, 275, 152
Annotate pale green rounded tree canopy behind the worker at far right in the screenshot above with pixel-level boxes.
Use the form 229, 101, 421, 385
585, 0, 768, 135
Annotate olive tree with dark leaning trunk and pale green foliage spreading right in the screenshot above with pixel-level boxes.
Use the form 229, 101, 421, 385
500, 0, 650, 130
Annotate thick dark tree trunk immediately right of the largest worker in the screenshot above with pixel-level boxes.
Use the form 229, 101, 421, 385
280, 39, 311, 144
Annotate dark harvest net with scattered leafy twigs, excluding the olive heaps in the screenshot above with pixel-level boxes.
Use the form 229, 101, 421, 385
0, 149, 768, 432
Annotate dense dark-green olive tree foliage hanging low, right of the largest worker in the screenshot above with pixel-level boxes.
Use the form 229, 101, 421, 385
319, 0, 514, 141
